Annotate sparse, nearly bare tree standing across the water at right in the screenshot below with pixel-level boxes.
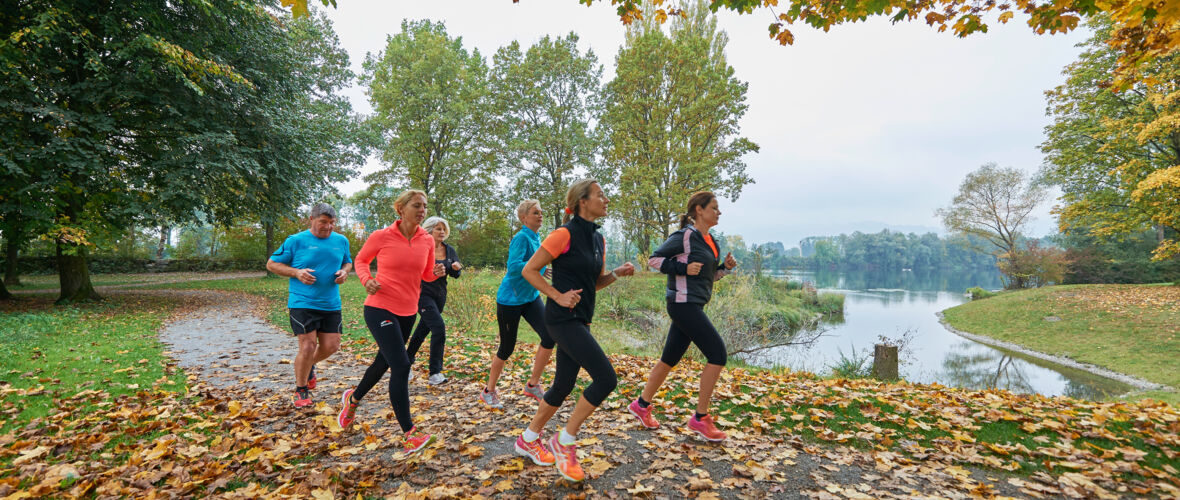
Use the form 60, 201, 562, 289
936, 163, 1048, 288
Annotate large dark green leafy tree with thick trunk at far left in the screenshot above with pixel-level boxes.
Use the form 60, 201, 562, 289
0, 0, 359, 301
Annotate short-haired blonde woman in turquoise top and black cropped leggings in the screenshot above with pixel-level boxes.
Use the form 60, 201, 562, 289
479, 199, 553, 408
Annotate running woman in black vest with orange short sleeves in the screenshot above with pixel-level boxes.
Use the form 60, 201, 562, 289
516, 179, 635, 481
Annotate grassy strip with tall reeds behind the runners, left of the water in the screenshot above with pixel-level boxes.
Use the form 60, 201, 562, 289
156, 270, 844, 355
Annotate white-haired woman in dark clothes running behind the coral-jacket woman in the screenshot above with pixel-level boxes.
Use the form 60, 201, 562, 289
406, 217, 463, 386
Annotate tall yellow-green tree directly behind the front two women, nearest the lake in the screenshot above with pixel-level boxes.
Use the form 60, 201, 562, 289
595, 0, 758, 264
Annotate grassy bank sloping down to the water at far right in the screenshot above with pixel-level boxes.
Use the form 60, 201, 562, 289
945, 285, 1180, 404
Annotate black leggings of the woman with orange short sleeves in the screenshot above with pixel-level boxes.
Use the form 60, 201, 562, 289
545, 320, 618, 407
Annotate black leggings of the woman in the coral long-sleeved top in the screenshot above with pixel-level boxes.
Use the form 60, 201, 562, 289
353, 305, 414, 433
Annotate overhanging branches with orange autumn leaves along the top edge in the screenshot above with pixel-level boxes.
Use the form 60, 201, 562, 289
283, 0, 1180, 81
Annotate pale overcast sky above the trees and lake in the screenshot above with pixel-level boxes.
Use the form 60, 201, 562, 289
313, 0, 1088, 246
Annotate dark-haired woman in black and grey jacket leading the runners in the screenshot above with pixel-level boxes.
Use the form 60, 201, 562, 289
627, 191, 738, 441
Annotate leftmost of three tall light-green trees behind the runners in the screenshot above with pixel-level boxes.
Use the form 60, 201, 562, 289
362, 20, 493, 223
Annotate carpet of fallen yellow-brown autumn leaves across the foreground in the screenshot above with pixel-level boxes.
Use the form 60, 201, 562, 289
0, 340, 1180, 499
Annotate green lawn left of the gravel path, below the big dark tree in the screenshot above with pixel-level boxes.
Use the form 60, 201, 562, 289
0, 295, 185, 433
